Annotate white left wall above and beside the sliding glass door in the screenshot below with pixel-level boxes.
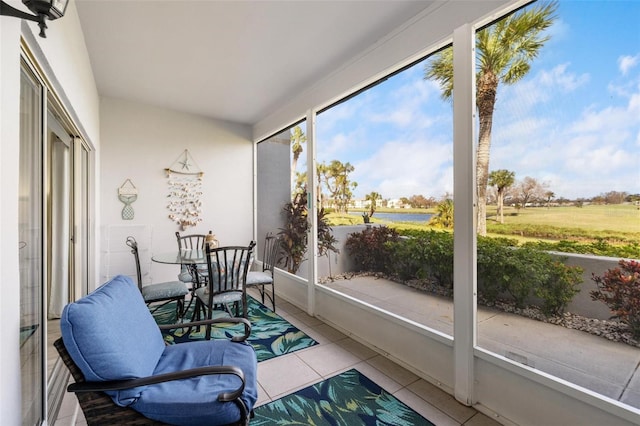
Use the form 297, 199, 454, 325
0, 1, 99, 425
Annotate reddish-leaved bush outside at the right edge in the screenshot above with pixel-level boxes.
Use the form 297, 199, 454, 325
591, 259, 640, 339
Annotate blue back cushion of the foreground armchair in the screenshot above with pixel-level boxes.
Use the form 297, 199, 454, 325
60, 275, 165, 405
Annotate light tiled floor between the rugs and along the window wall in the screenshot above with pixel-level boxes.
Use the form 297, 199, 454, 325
55, 292, 498, 426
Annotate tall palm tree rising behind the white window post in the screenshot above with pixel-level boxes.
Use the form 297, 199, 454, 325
425, 1, 557, 235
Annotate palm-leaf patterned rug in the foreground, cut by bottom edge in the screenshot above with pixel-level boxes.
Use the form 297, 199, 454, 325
251, 369, 435, 426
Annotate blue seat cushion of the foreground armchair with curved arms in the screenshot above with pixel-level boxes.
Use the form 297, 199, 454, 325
131, 340, 258, 425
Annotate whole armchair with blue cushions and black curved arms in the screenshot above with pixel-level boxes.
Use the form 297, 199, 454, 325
55, 275, 257, 425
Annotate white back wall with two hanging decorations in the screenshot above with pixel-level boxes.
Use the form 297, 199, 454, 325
100, 98, 253, 282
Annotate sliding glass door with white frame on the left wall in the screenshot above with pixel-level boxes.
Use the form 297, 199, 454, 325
18, 55, 91, 425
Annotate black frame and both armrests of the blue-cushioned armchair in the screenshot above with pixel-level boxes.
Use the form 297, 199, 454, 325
53, 318, 253, 426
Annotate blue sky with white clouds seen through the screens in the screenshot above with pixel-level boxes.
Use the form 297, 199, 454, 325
317, 0, 640, 199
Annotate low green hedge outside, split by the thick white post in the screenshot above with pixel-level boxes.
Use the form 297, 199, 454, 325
346, 227, 582, 315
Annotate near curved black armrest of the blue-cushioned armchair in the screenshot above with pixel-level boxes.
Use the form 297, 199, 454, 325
67, 365, 245, 402
